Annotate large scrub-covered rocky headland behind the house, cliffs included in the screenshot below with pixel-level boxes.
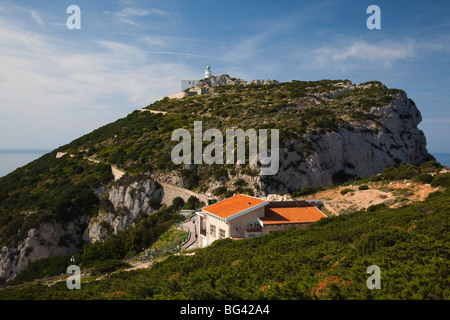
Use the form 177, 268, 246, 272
0, 76, 433, 280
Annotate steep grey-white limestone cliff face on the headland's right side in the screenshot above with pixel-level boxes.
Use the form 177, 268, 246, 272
255, 93, 428, 194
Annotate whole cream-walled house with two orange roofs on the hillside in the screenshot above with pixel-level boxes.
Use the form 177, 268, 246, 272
196, 194, 326, 248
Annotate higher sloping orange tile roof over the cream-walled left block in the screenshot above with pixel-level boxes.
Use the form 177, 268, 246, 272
203, 194, 267, 219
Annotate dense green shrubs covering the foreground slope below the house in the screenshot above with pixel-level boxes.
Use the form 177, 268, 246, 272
0, 175, 450, 299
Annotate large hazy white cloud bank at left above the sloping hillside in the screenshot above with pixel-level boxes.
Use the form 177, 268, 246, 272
0, 14, 192, 148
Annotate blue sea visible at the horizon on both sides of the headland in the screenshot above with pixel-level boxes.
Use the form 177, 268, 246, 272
0, 150, 450, 177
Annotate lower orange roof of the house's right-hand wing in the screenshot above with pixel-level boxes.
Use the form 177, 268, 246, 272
260, 206, 326, 226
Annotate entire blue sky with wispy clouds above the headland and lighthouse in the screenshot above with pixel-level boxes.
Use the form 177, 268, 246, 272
0, 0, 450, 153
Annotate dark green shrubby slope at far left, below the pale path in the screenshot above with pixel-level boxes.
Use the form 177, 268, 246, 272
0, 152, 113, 247
